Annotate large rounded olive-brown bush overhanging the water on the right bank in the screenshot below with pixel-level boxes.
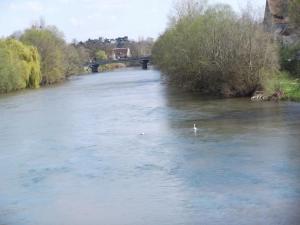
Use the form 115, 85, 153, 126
152, 1, 278, 97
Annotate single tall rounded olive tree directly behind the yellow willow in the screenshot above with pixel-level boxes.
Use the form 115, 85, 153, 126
20, 28, 67, 85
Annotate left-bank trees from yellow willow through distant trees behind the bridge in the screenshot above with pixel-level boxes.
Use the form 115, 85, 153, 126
0, 19, 153, 93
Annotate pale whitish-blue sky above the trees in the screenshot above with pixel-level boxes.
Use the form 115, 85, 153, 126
0, 0, 265, 41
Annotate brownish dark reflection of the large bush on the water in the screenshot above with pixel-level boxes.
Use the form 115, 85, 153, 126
165, 84, 300, 135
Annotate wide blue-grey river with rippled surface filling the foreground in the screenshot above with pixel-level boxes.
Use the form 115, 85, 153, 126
0, 69, 300, 225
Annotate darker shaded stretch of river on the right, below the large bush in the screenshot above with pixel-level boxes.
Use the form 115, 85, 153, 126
162, 83, 300, 224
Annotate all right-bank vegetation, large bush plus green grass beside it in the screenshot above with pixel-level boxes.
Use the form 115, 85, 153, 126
152, 0, 300, 100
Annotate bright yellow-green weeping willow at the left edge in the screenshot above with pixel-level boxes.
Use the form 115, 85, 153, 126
0, 39, 41, 93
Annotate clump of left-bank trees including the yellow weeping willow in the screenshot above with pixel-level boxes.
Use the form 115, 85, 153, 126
0, 22, 89, 93
